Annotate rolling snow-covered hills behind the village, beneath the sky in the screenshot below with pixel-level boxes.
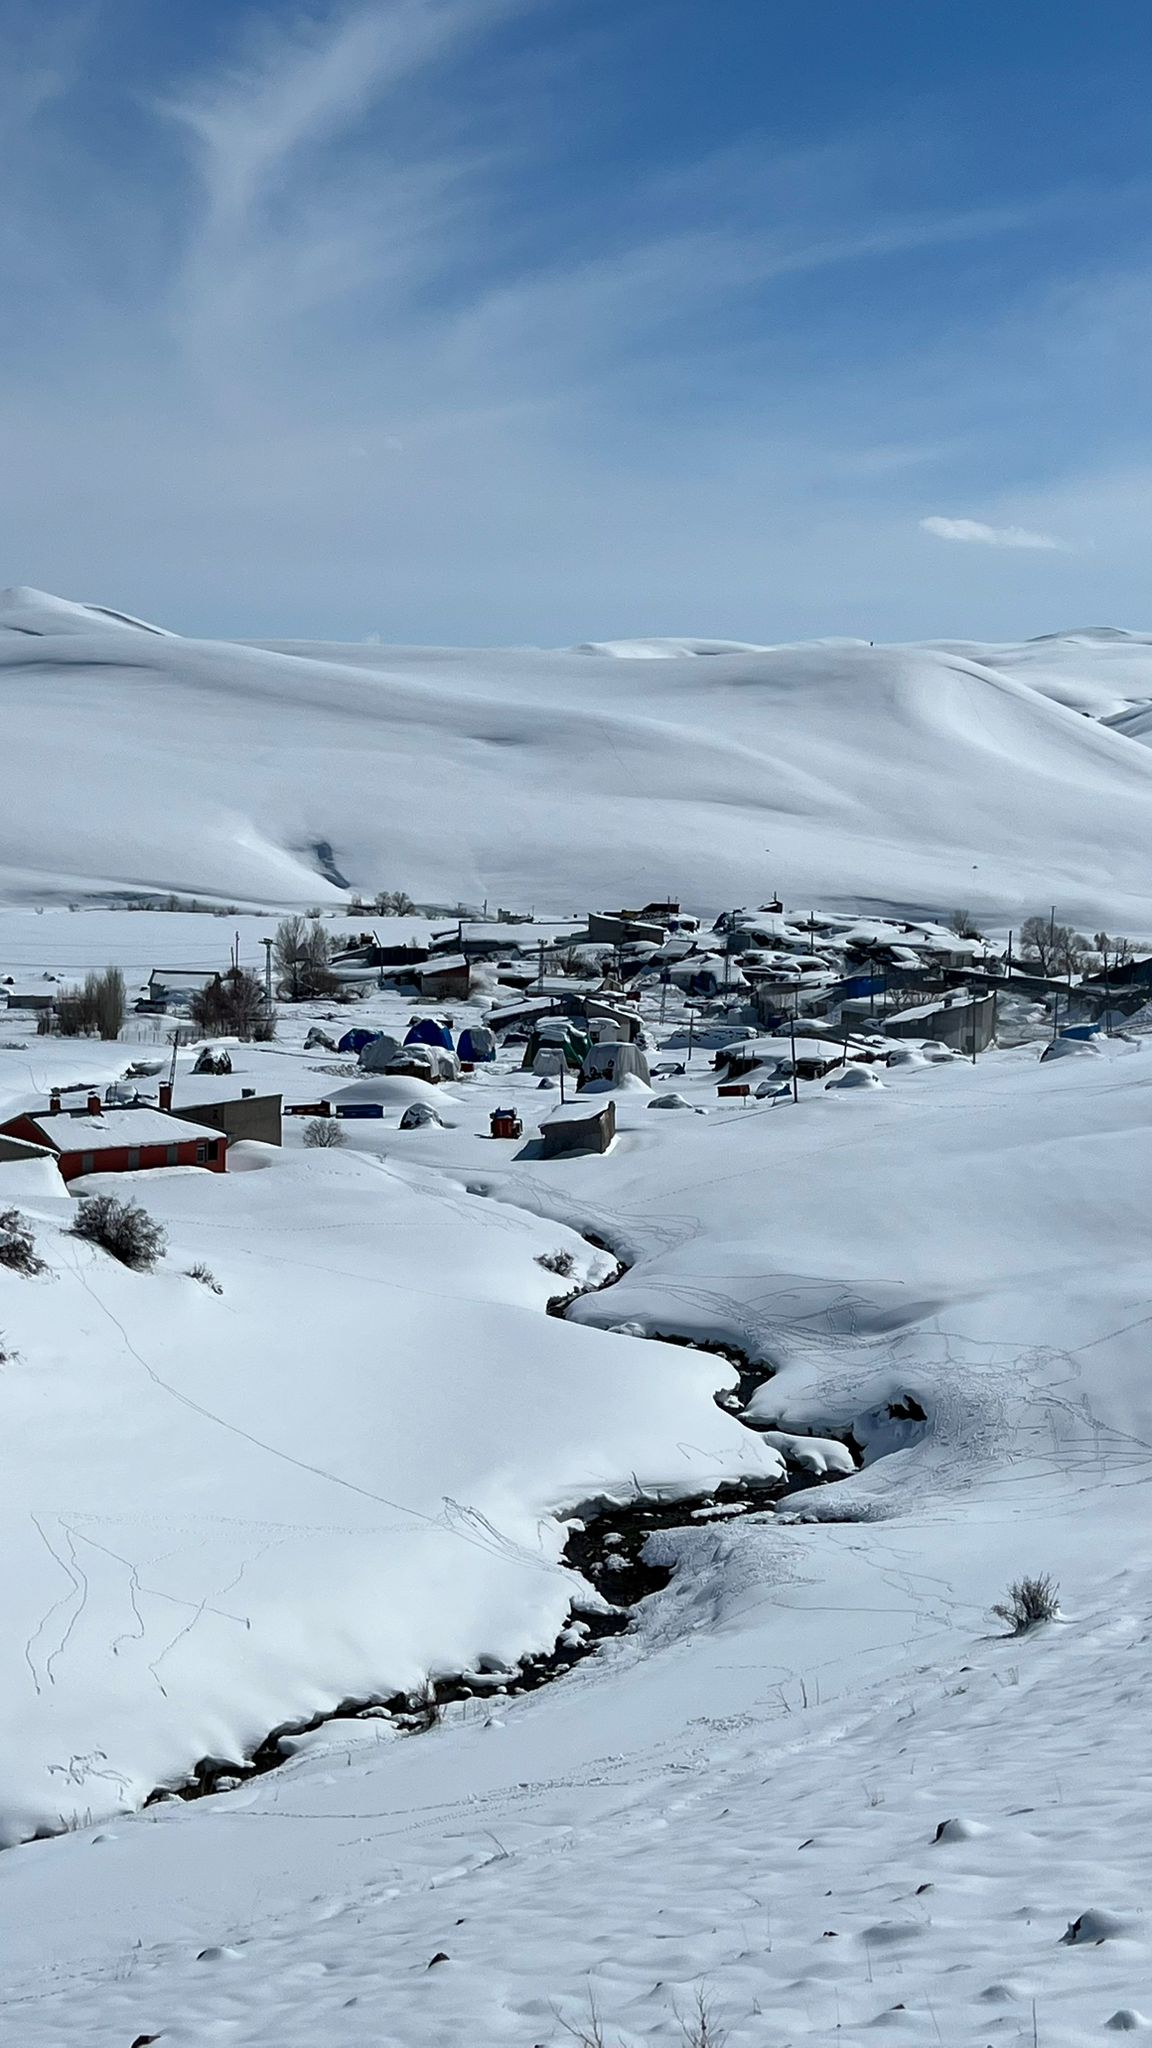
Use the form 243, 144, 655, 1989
0, 592, 1152, 928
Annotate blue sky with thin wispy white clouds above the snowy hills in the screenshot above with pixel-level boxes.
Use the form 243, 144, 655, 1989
0, 0, 1152, 643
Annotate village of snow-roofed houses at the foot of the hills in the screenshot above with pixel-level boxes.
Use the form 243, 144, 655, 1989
0, 899, 1152, 1182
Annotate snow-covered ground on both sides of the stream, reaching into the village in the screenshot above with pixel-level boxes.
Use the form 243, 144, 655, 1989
0, 913, 1152, 2048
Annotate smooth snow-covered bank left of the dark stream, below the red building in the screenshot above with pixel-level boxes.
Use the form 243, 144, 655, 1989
0, 1153, 770, 1843
